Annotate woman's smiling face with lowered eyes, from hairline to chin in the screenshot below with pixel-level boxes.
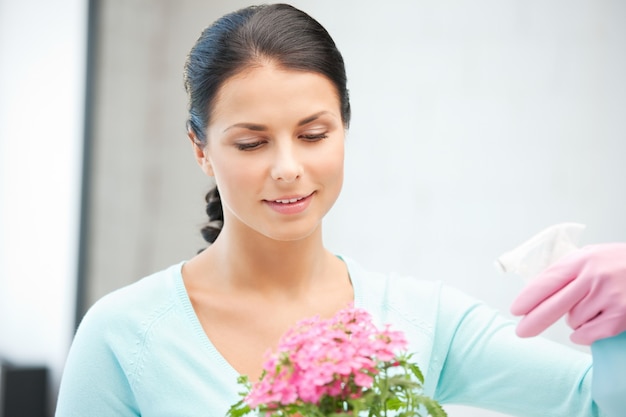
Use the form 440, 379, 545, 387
194, 64, 345, 241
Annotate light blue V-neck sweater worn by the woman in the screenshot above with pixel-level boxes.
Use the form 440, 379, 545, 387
56, 258, 600, 417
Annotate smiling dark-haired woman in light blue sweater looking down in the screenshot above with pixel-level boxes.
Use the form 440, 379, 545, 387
57, 5, 626, 417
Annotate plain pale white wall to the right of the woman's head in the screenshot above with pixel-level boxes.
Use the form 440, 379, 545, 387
310, 0, 626, 324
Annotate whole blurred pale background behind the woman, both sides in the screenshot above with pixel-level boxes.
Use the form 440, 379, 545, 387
0, 0, 626, 417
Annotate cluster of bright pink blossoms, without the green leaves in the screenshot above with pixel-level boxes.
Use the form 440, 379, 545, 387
245, 307, 406, 409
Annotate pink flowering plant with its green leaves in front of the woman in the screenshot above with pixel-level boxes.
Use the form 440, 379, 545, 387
228, 307, 446, 417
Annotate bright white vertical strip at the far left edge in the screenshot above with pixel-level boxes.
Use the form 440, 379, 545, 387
0, 0, 87, 401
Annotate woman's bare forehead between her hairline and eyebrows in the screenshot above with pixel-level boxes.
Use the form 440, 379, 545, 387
210, 64, 340, 124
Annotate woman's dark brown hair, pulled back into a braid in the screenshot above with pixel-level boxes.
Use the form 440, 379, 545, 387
185, 4, 350, 243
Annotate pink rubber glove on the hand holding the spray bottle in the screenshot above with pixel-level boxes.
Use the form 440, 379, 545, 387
511, 243, 626, 345
